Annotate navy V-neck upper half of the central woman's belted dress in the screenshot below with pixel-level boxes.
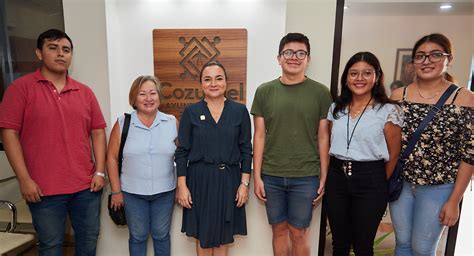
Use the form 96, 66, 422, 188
175, 99, 252, 176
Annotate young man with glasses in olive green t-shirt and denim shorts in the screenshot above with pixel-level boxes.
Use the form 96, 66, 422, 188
251, 33, 332, 256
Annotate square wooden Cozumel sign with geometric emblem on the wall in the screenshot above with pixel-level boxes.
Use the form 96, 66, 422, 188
153, 29, 247, 118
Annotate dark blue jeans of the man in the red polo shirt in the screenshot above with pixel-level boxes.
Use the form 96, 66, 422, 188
28, 189, 102, 256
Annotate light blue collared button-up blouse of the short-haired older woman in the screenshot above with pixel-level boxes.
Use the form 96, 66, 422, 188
118, 111, 178, 195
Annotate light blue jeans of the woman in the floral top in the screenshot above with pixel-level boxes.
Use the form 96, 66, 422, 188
390, 182, 454, 256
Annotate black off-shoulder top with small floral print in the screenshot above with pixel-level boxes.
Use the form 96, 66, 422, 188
402, 92, 474, 185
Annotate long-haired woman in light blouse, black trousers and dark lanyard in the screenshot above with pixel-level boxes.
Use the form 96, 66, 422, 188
320, 52, 402, 256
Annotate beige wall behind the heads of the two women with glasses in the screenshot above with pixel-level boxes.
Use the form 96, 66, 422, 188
340, 15, 474, 90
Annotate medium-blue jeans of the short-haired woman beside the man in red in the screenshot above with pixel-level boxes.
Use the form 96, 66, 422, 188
123, 190, 175, 256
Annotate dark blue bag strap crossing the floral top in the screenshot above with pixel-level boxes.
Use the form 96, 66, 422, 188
401, 84, 458, 159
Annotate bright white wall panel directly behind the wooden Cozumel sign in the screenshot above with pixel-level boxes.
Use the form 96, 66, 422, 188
103, 0, 286, 255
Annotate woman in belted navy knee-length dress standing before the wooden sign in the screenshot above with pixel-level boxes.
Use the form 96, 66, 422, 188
175, 61, 252, 256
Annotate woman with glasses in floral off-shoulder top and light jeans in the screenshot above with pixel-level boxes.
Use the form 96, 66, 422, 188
390, 34, 474, 255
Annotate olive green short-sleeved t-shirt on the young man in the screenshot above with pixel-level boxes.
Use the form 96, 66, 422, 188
251, 78, 332, 177
